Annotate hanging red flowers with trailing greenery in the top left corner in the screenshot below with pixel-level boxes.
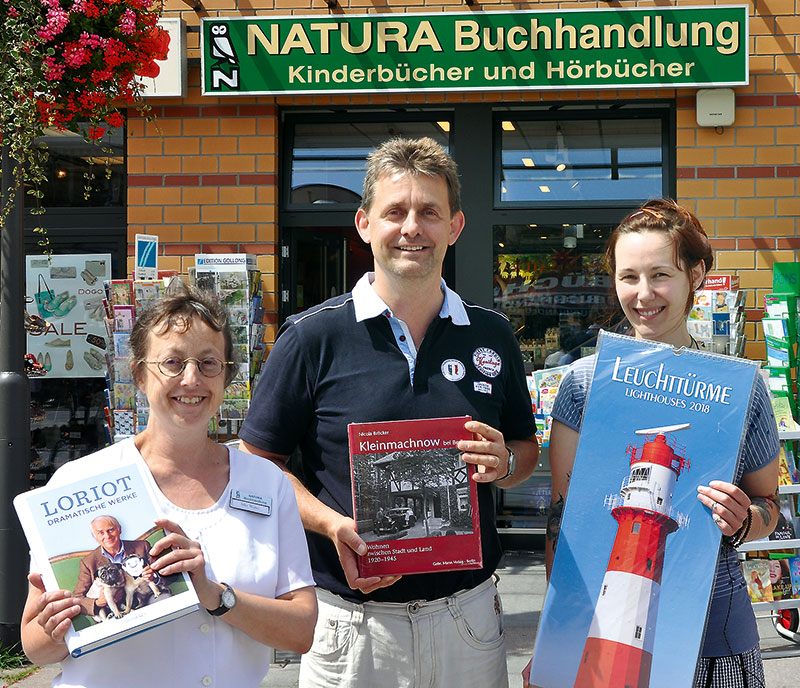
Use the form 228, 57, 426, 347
0, 0, 169, 215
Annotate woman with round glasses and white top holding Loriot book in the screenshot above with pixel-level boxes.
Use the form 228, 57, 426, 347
22, 291, 317, 688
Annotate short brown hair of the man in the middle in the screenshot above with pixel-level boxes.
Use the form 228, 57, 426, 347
361, 136, 461, 214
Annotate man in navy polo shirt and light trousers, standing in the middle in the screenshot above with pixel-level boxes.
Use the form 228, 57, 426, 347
239, 138, 538, 688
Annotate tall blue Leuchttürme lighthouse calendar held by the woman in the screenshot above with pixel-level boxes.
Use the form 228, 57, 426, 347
531, 332, 759, 688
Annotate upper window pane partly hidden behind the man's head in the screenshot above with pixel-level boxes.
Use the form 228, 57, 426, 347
290, 115, 450, 205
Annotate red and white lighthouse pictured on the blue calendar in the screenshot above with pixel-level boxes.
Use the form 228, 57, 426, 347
575, 423, 689, 688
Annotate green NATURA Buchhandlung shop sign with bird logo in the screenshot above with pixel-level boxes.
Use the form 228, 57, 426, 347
201, 5, 748, 95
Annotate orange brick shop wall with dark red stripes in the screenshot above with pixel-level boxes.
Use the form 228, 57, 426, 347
128, 0, 800, 358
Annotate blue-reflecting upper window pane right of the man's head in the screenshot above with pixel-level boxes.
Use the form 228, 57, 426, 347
500, 113, 664, 203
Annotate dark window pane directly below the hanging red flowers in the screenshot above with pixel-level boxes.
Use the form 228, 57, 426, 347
31, 129, 125, 208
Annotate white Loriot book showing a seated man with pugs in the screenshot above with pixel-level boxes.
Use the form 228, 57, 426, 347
14, 462, 199, 657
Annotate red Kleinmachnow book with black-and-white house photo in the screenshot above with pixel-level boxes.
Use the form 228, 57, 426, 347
348, 416, 483, 578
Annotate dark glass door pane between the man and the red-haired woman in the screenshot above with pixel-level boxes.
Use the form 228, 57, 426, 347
493, 224, 620, 372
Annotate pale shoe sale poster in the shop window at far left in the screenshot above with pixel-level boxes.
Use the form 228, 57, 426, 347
25, 253, 111, 378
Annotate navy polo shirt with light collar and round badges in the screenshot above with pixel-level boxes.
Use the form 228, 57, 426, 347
239, 278, 536, 602
